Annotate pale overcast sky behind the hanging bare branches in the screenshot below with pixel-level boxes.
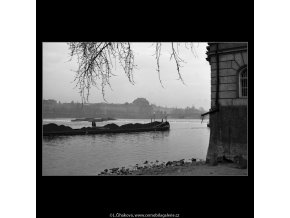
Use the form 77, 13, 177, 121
43, 43, 210, 110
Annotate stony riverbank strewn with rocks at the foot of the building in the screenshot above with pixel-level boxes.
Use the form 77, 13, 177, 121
98, 158, 248, 176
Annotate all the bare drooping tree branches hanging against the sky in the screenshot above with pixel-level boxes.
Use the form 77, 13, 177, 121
68, 42, 196, 103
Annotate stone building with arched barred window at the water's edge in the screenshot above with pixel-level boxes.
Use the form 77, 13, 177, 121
207, 43, 248, 161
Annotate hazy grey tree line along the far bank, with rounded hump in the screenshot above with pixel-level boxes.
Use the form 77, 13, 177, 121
42, 98, 205, 119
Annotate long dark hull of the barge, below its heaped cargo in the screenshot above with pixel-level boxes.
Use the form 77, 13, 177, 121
43, 125, 170, 136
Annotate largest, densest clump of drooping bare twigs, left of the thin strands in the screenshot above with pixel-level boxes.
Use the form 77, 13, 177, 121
68, 42, 135, 102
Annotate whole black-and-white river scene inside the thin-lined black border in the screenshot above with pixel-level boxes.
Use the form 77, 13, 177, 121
42, 42, 251, 176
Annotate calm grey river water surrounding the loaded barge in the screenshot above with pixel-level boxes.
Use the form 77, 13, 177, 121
42, 118, 210, 175
